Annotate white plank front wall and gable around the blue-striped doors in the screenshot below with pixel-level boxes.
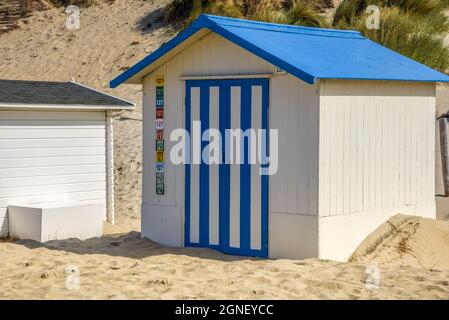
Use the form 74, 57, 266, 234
142, 33, 319, 245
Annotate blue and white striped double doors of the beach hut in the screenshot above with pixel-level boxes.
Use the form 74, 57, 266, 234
185, 79, 268, 257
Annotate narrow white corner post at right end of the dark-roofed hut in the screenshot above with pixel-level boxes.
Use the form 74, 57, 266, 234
106, 110, 115, 224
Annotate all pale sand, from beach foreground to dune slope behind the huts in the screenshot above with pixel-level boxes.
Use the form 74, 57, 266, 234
0, 0, 449, 299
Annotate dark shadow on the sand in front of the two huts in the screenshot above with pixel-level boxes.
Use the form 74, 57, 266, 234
15, 231, 259, 261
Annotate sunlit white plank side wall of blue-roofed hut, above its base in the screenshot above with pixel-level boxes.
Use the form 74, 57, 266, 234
319, 80, 435, 217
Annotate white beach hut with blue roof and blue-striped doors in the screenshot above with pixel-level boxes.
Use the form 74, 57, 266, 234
110, 15, 449, 260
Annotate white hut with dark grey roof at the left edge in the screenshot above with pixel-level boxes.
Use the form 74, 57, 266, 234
0, 80, 135, 241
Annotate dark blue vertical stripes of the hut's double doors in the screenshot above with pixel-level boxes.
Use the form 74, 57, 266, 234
185, 79, 269, 257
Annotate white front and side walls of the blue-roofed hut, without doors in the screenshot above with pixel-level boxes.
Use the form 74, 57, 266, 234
142, 33, 435, 260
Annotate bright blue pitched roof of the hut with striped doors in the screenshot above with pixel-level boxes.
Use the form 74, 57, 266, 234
110, 14, 449, 88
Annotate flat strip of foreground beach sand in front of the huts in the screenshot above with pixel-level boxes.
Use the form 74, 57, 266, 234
0, 225, 449, 299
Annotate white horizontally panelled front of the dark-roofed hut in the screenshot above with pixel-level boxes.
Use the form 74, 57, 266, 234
0, 111, 106, 235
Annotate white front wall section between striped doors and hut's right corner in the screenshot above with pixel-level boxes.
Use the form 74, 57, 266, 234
269, 75, 318, 215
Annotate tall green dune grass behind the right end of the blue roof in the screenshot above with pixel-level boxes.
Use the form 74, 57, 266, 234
332, 0, 449, 72
